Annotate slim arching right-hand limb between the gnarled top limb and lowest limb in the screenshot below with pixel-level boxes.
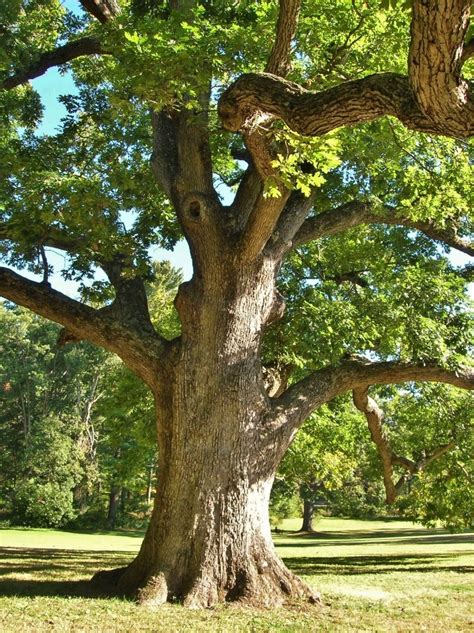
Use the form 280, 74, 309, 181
292, 200, 474, 256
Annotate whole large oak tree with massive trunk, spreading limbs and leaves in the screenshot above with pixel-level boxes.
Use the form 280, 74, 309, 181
0, 0, 474, 607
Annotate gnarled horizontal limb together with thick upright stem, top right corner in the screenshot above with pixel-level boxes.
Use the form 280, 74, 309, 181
219, 0, 474, 138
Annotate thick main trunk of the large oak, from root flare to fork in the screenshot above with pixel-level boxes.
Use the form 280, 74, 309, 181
92, 256, 317, 608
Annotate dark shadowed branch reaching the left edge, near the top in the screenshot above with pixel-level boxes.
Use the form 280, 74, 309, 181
1, 37, 105, 90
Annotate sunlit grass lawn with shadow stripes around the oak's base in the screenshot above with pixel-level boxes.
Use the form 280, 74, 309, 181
0, 518, 474, 633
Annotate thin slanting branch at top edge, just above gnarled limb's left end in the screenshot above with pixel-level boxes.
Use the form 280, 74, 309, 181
265, 0, 301, 77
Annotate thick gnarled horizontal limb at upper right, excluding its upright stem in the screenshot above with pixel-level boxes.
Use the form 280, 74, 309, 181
218, 73, 474, 138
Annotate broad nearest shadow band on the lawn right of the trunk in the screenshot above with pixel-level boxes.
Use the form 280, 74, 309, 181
283, 553, 474, 576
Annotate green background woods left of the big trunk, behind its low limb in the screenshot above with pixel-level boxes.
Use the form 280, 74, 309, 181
0, 262, 181, 528
